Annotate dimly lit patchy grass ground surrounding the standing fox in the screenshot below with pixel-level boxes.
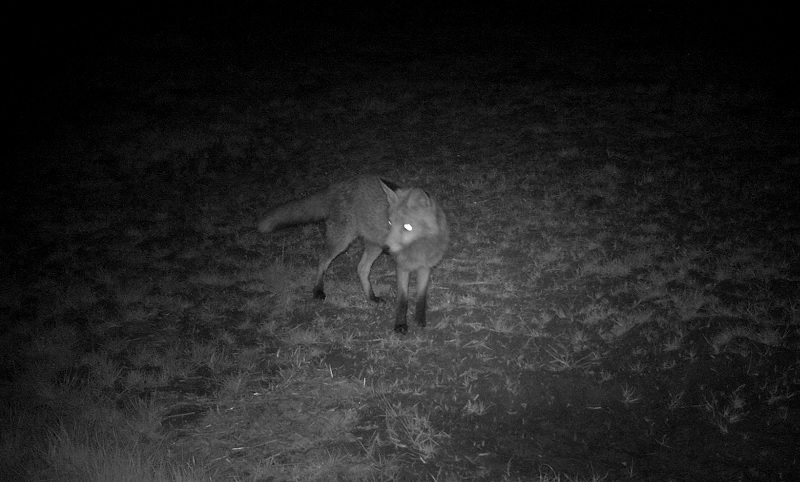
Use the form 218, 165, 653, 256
0, 17, 800, 481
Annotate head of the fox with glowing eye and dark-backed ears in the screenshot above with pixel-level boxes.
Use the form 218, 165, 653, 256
381, 182, 439, 253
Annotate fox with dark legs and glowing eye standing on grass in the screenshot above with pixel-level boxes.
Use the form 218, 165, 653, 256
257, 175, 450, 334
